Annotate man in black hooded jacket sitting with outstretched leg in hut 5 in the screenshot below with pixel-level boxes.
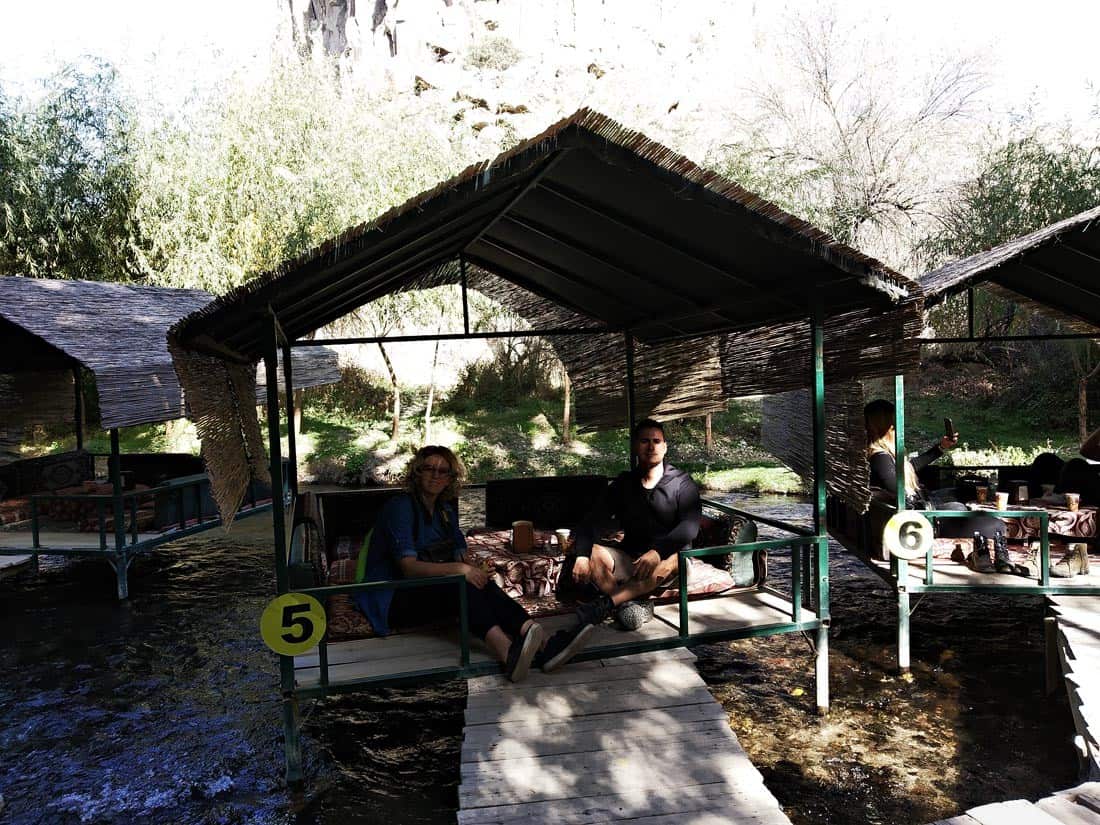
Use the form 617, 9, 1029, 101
543, 418, 703, 670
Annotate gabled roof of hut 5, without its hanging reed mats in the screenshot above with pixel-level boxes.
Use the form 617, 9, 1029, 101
169, 109, 914, 361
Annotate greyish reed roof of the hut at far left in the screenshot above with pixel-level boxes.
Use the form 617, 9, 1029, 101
0, 276, 340, 429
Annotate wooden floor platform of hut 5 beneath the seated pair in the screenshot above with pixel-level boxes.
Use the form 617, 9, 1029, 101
294, 591, 815, 688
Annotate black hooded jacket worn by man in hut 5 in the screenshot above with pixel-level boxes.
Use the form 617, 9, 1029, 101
576, 464, 703, 559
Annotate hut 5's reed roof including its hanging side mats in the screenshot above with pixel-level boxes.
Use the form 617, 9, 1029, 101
169, 109, 920, 513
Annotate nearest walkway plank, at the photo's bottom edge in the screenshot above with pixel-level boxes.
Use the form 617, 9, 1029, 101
458, 782, 787, 825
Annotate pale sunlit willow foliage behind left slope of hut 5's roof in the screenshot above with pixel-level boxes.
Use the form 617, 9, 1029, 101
139, 49, 463, 294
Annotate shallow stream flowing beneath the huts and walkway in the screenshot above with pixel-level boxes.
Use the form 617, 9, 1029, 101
0, 492, 1076, 825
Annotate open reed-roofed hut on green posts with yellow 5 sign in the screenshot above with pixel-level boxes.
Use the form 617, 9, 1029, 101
169, 110, 920, 782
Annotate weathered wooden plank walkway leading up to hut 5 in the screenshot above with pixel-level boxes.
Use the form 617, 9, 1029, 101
458, 651, 790, 825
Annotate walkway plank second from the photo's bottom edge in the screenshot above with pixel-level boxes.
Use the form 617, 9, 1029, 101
459, 746, 767, 807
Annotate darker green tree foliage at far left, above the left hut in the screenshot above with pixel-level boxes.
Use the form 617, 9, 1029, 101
0, 61, 146, 281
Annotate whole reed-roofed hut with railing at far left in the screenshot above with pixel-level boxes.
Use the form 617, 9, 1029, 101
0, 276, 339, 598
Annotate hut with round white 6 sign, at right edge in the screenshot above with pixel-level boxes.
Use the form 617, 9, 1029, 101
765, 208, 1100, 671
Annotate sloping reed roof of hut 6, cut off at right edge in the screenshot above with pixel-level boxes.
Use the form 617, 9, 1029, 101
920, 206, 1100, 327
